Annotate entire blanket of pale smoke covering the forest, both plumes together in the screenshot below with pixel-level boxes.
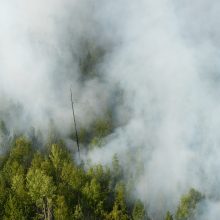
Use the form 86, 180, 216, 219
0, 0, 220, 219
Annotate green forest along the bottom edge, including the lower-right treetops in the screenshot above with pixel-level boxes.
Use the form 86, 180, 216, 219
0, 117, 204, 220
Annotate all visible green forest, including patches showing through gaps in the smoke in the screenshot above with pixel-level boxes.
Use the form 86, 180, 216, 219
0, 31, 205, 220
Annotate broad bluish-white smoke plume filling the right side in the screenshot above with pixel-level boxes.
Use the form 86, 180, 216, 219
88, 0, 220, 219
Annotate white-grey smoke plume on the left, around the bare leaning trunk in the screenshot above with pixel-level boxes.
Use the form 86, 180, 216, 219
0, 0, 113, 137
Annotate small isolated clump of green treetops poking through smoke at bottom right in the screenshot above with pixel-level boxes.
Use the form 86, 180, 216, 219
175, 189, 204, 220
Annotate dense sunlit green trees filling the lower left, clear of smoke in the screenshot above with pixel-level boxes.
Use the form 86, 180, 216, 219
0, 137, 132, 220
